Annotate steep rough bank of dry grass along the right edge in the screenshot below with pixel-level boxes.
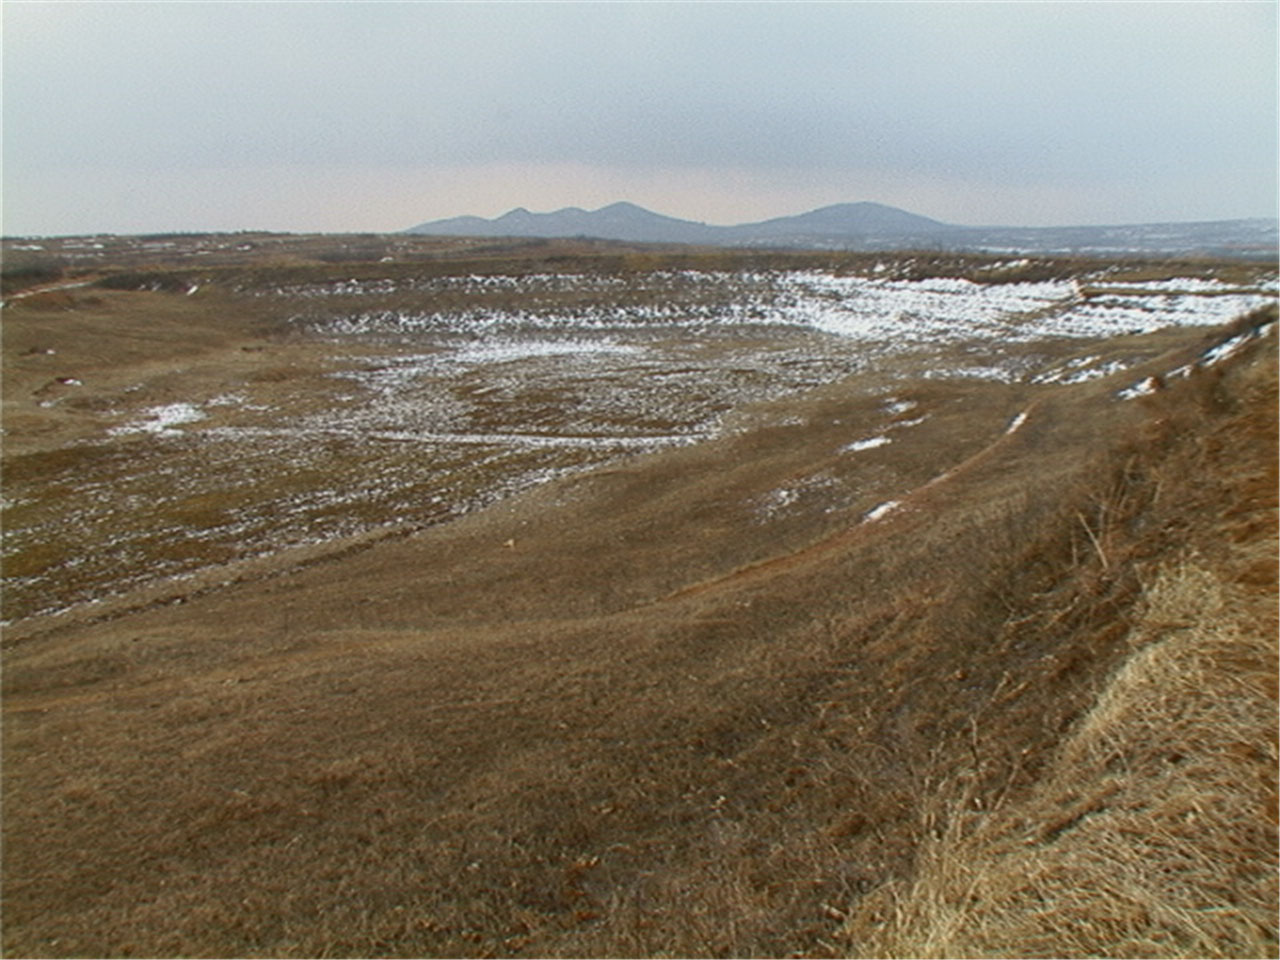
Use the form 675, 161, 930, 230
844, 335, 1277, 956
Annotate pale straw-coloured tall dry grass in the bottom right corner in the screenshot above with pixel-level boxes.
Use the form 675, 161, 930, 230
845, 519, 1277, 957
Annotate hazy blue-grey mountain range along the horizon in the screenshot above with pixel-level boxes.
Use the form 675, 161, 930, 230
406, 202, 1280, 259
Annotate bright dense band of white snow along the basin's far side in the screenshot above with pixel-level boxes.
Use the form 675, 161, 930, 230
323, 270, 1272, 360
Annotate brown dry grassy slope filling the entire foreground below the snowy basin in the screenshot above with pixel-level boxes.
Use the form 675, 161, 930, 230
4, 273, 1276, 956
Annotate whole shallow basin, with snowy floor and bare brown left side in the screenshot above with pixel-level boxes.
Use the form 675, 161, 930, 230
3, 261, 1275, 625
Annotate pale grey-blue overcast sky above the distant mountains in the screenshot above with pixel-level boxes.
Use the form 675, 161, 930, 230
0, 0, 1277, 236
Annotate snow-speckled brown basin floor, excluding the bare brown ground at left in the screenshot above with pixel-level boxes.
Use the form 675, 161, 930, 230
4, 264, 1274, 618
